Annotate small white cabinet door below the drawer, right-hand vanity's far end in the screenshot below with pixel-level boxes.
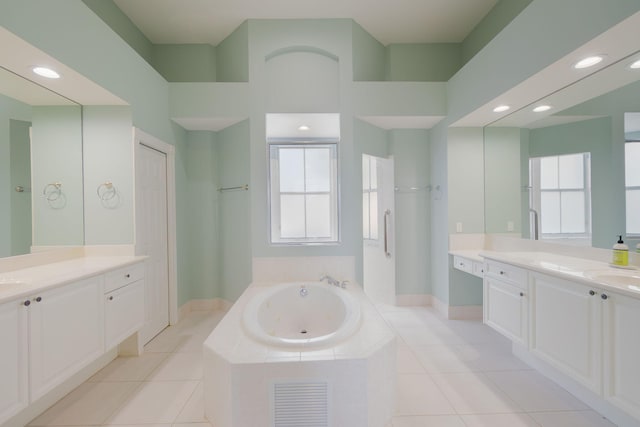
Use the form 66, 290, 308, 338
484, 277, 527, 345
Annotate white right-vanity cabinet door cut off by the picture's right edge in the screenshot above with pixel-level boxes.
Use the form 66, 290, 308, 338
603, 292, 640, 419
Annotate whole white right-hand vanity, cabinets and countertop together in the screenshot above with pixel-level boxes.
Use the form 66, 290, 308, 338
468, 250, 640, 426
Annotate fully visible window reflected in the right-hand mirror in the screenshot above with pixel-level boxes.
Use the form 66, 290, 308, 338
530, 153, 591, 240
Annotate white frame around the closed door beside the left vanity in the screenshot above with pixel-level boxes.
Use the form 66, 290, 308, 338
133, 127, 180, 325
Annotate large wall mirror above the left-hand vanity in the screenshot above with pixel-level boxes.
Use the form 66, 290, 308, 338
0, 67, 84, 257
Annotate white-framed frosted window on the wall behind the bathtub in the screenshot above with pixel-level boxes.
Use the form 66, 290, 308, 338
269, 143, 338, 244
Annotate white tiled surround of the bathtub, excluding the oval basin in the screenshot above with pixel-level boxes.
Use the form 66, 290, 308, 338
203, 282, 396, 427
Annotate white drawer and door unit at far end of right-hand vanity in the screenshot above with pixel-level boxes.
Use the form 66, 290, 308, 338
483, 261, 529, 346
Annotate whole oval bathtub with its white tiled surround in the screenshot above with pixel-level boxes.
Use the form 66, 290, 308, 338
203, 281, 396, 427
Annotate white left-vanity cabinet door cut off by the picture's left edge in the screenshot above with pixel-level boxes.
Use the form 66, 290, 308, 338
0, 301, 29, 425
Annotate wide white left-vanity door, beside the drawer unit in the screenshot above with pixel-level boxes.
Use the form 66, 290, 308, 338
29, 276, 104, 400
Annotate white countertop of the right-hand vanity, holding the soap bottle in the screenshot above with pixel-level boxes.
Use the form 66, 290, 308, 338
478, 250, 640, 298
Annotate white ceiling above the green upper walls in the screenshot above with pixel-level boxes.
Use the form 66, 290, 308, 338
114, 0, 497, 46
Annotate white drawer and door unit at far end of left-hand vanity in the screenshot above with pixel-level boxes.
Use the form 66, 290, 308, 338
104, 264, 145, 350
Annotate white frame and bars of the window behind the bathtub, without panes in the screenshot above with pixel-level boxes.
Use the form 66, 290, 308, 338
267, 141, 340, 245
